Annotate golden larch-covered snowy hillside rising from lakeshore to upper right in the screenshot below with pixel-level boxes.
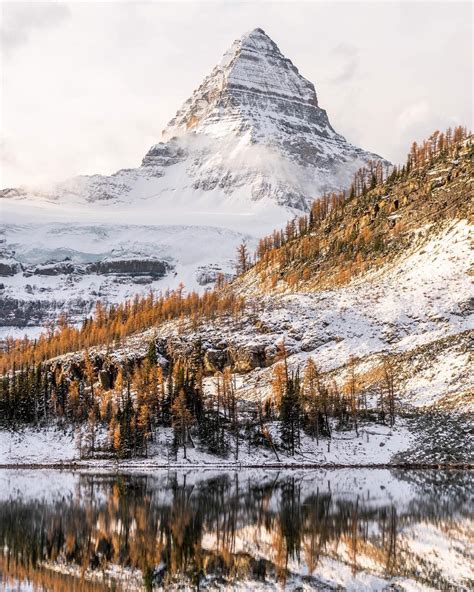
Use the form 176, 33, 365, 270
0, 128, 472, 464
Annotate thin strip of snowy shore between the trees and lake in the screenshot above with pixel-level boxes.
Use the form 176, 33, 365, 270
0, 421, 413, 468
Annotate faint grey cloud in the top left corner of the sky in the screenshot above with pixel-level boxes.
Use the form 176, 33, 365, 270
0, 2, 70, 54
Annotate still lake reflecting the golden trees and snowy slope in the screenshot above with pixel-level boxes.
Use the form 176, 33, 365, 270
0, 469, 474, 592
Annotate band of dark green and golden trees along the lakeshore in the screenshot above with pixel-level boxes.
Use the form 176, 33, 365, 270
0, 340, 396, 461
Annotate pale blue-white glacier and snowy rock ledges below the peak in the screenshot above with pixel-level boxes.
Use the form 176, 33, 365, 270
0, 223, 255, 330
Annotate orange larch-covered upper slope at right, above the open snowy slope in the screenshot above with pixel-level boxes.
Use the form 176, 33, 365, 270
244, 127, 473, 291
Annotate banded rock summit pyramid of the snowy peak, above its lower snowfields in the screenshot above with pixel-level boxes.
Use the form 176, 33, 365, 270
164, 29, 372, 170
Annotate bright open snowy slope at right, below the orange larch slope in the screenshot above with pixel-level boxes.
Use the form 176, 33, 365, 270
241, 220, 474, 370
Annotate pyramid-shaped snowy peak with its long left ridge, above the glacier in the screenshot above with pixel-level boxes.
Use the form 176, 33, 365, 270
2, 29, 386, 211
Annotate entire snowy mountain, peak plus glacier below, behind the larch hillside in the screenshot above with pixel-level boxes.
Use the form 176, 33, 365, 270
0, 29, 388, 325
